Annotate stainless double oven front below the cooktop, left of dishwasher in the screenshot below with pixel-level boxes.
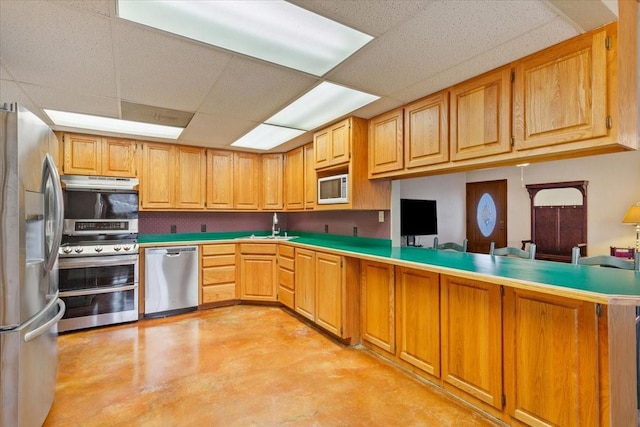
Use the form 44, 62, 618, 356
58, 254, 138, 331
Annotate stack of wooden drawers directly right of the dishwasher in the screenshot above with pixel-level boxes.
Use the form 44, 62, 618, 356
200, 243, 237, 304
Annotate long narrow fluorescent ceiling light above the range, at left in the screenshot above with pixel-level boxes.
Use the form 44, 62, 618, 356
44, 110, 184, 139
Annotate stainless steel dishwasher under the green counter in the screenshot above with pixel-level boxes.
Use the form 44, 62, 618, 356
144, 246, 198, 317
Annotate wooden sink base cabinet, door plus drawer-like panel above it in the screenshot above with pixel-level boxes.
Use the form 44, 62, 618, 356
240, 243, 277, 301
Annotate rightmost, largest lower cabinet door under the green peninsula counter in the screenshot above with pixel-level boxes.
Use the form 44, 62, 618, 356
504, 288, 600, 426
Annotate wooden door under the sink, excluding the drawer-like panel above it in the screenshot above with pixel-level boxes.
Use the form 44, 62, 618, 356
240, 255, 277, 301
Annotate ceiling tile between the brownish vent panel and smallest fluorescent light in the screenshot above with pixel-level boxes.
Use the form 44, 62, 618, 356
179, 113, 258, 149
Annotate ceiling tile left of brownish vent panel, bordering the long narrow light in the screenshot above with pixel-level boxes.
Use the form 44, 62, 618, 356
22, 84, 120, 119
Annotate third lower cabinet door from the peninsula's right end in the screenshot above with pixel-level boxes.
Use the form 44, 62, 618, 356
396, 267, 440, 377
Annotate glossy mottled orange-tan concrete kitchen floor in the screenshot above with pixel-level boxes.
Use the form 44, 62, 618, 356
44, 305, 498, 427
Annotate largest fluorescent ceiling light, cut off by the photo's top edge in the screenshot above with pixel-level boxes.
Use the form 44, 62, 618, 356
118, 0, 373, 76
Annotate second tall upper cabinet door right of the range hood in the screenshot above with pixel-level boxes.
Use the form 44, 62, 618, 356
175, 146, 207, 209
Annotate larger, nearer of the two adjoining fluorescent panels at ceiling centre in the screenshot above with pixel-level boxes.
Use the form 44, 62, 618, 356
265, 82, 380, 130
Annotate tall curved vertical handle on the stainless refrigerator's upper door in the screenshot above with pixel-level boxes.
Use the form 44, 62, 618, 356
40, 154, 64, 271
